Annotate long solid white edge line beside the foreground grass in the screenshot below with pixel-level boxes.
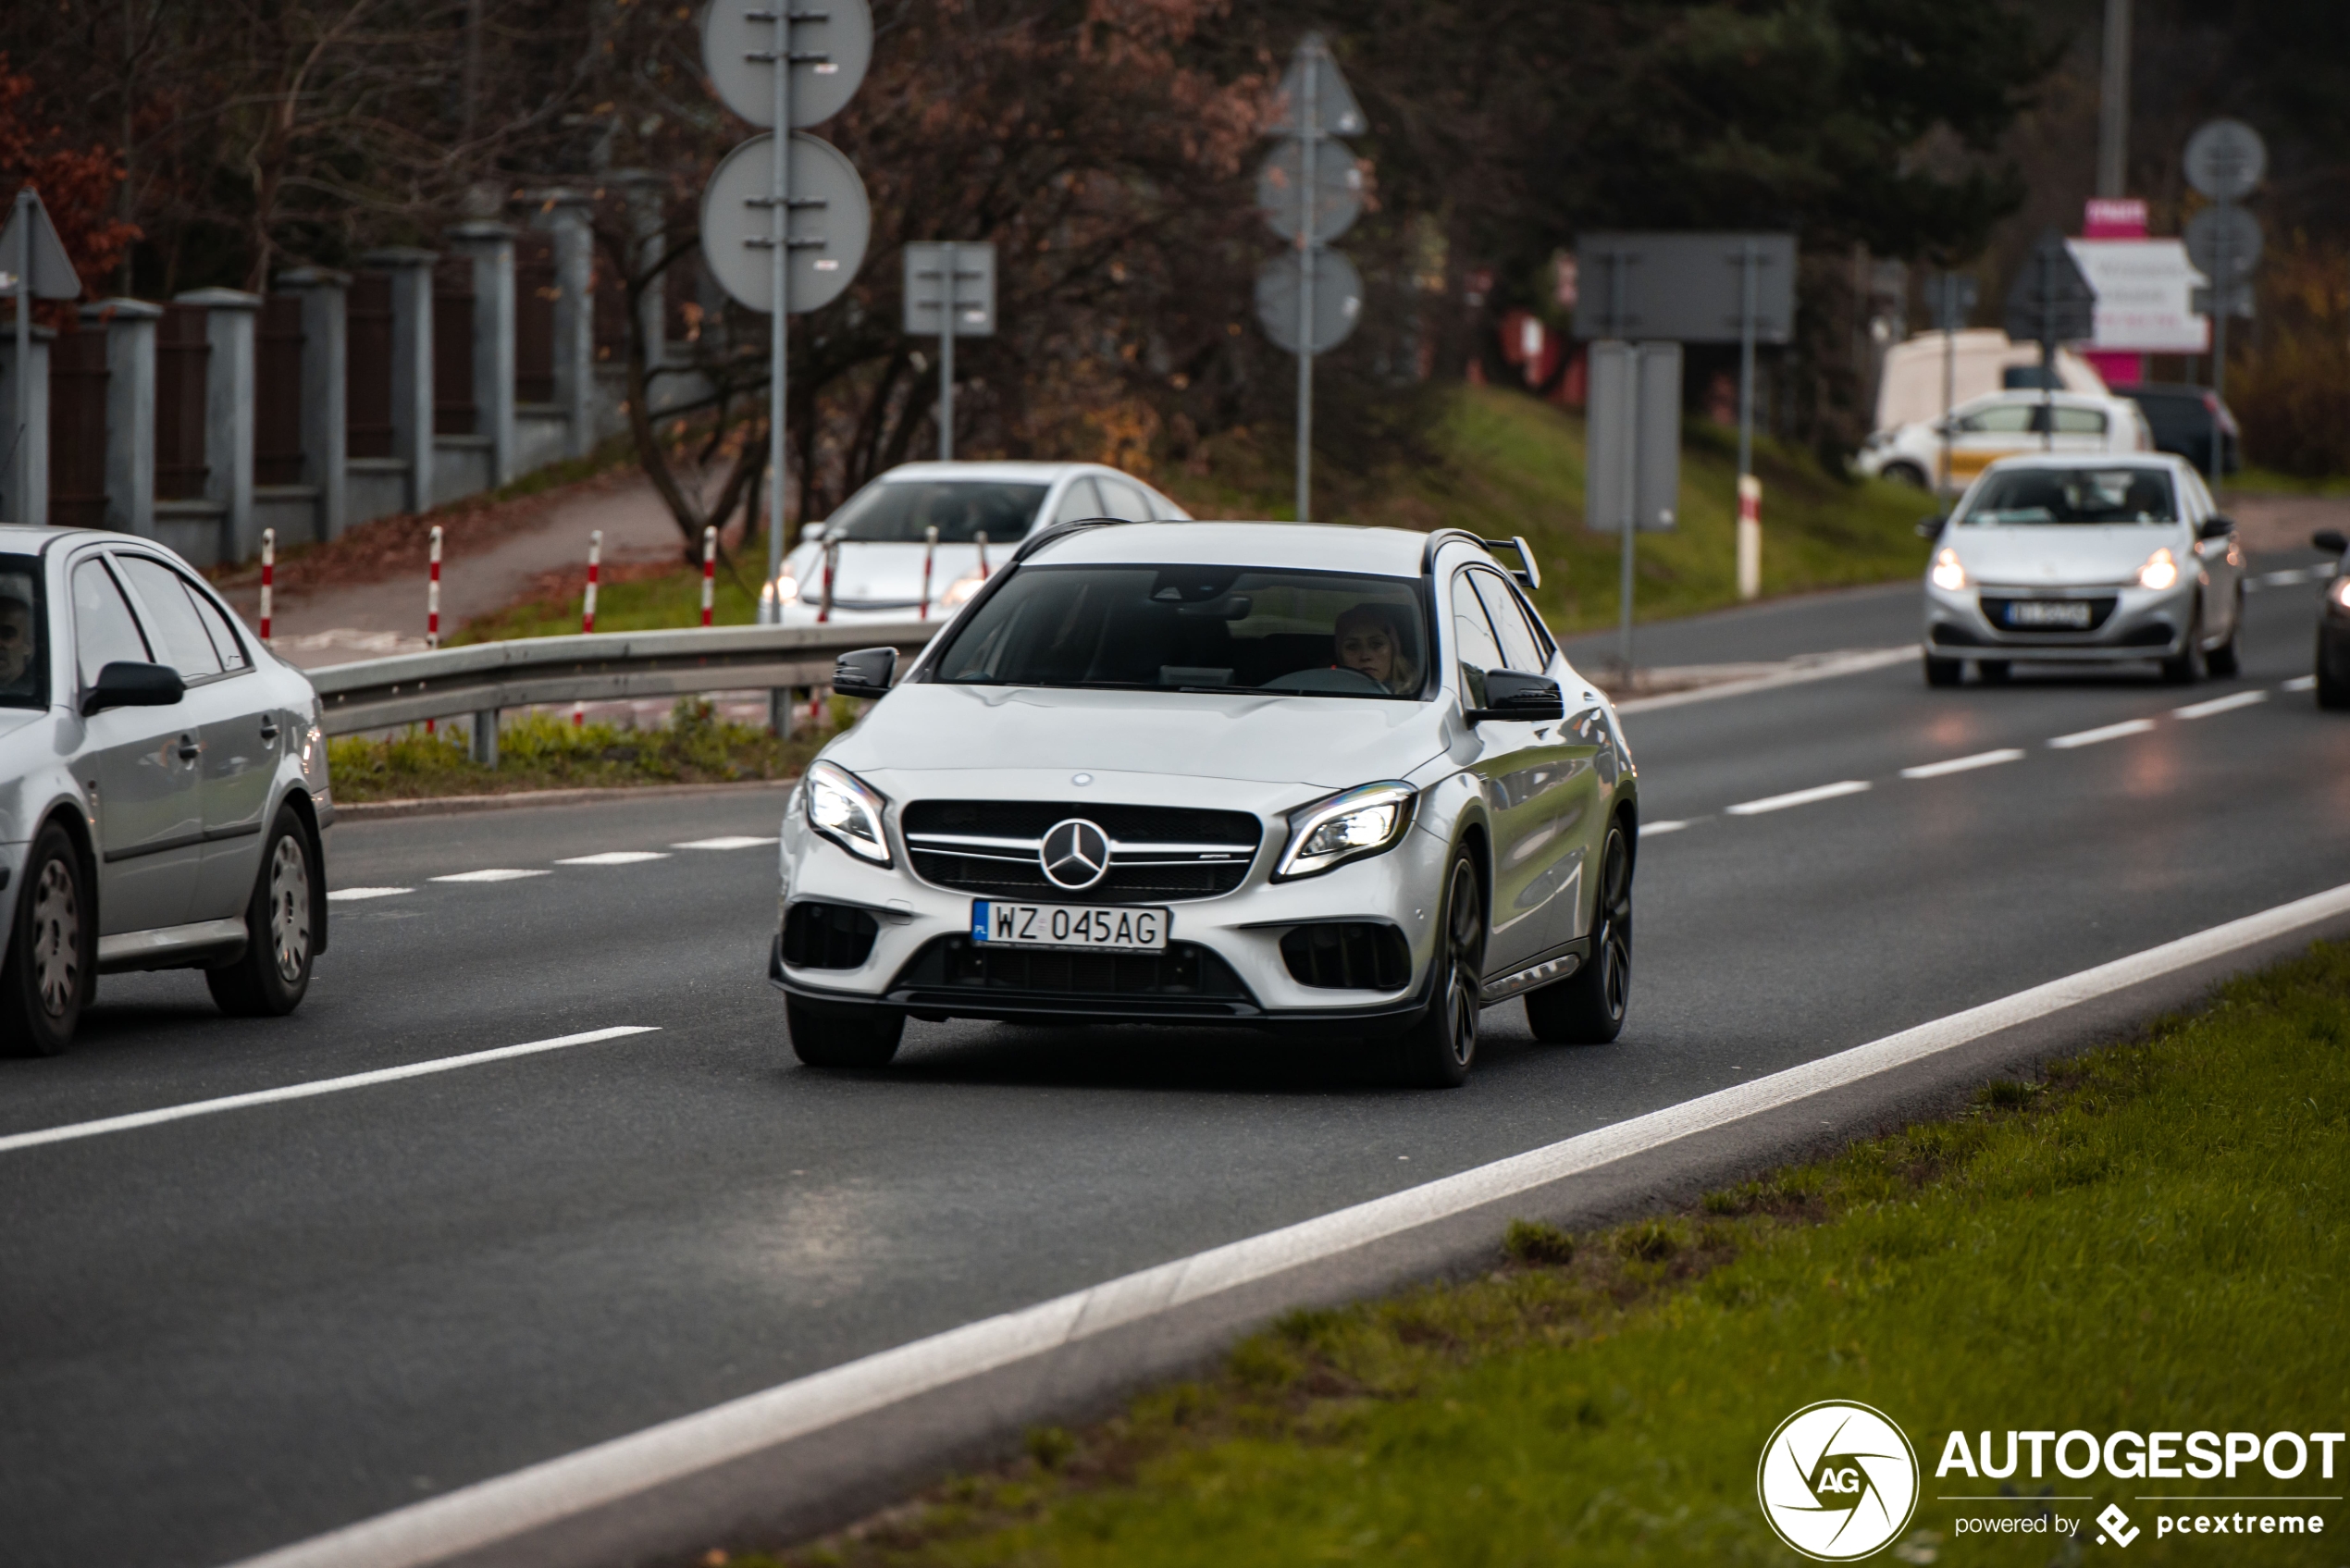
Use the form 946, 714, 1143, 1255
224, 886, 2350, 1568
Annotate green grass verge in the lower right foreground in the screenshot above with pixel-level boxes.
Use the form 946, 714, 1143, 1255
747, 945, 2350, 1568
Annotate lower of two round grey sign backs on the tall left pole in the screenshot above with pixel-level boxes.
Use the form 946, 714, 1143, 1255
702, 131, 872, 315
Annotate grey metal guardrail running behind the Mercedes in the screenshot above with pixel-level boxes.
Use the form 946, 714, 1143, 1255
305, 621, 945, 761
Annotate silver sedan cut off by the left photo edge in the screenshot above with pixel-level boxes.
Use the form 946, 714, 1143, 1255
0, 526, 334, 1053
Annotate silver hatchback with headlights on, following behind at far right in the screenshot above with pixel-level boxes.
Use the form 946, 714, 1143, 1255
1918, 453, 2245, 686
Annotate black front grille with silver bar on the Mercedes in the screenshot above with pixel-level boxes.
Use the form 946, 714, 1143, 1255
900, 799, 1265, 903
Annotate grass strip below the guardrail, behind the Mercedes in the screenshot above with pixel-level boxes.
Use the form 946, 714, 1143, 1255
327, 698, 848, 804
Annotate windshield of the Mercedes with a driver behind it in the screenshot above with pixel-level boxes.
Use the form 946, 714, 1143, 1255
935, 566, 1429, 698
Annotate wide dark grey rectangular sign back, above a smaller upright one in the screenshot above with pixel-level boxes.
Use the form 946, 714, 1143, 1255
1575, 233, 1796, 343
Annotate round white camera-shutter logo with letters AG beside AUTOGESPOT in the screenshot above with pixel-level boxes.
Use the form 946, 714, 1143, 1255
1755, 1399, 1918, 1563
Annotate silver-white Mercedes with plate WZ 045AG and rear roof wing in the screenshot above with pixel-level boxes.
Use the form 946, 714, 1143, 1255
769, 522, 1638, 1086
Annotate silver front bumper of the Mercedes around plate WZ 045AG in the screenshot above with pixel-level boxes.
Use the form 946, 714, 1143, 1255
769, 776, 1450, 1034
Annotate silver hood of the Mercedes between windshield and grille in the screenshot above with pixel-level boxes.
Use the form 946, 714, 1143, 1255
825, 682, 1443, 795
